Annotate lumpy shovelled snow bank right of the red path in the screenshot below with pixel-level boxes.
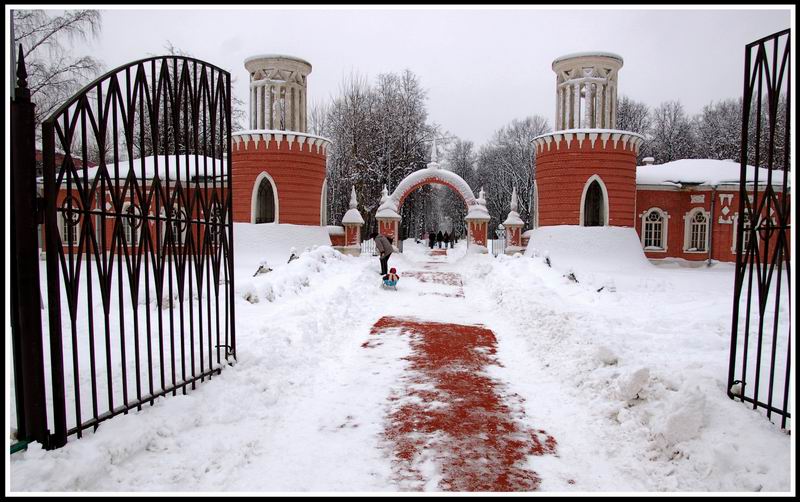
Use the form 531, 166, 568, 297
462, 251, 791, 491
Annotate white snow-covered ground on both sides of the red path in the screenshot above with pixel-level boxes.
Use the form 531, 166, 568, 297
10, 226, 794, 492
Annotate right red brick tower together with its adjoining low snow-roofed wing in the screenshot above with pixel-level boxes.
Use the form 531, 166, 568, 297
534, 52, 789, 262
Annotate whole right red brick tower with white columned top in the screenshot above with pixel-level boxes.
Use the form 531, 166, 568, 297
534, 52, 643, 227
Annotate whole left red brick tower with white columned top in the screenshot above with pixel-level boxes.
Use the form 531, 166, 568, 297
231, 55, 330, 225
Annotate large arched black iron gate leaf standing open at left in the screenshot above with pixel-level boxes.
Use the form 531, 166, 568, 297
42, 56, 236, 447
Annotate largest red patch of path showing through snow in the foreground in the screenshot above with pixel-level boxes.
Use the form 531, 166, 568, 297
363, 317, 556, 492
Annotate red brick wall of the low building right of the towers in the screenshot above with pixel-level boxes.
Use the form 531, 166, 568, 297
636, 187, 782, 262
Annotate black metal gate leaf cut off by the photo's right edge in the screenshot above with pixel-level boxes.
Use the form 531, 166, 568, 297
728, 30, 793, 429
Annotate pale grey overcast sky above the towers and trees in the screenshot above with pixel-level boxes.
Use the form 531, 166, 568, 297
31, 7, 792, 145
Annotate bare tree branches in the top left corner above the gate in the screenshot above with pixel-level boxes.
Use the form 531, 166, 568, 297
13, 10, 102, 124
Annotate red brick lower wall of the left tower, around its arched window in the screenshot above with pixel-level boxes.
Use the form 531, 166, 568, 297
232, 137, 326, 225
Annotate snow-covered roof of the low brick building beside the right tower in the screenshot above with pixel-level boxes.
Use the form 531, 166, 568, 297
636, 159, 783, 187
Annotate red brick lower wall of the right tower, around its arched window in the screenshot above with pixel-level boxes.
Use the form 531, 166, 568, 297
536, 138, 636, 227
